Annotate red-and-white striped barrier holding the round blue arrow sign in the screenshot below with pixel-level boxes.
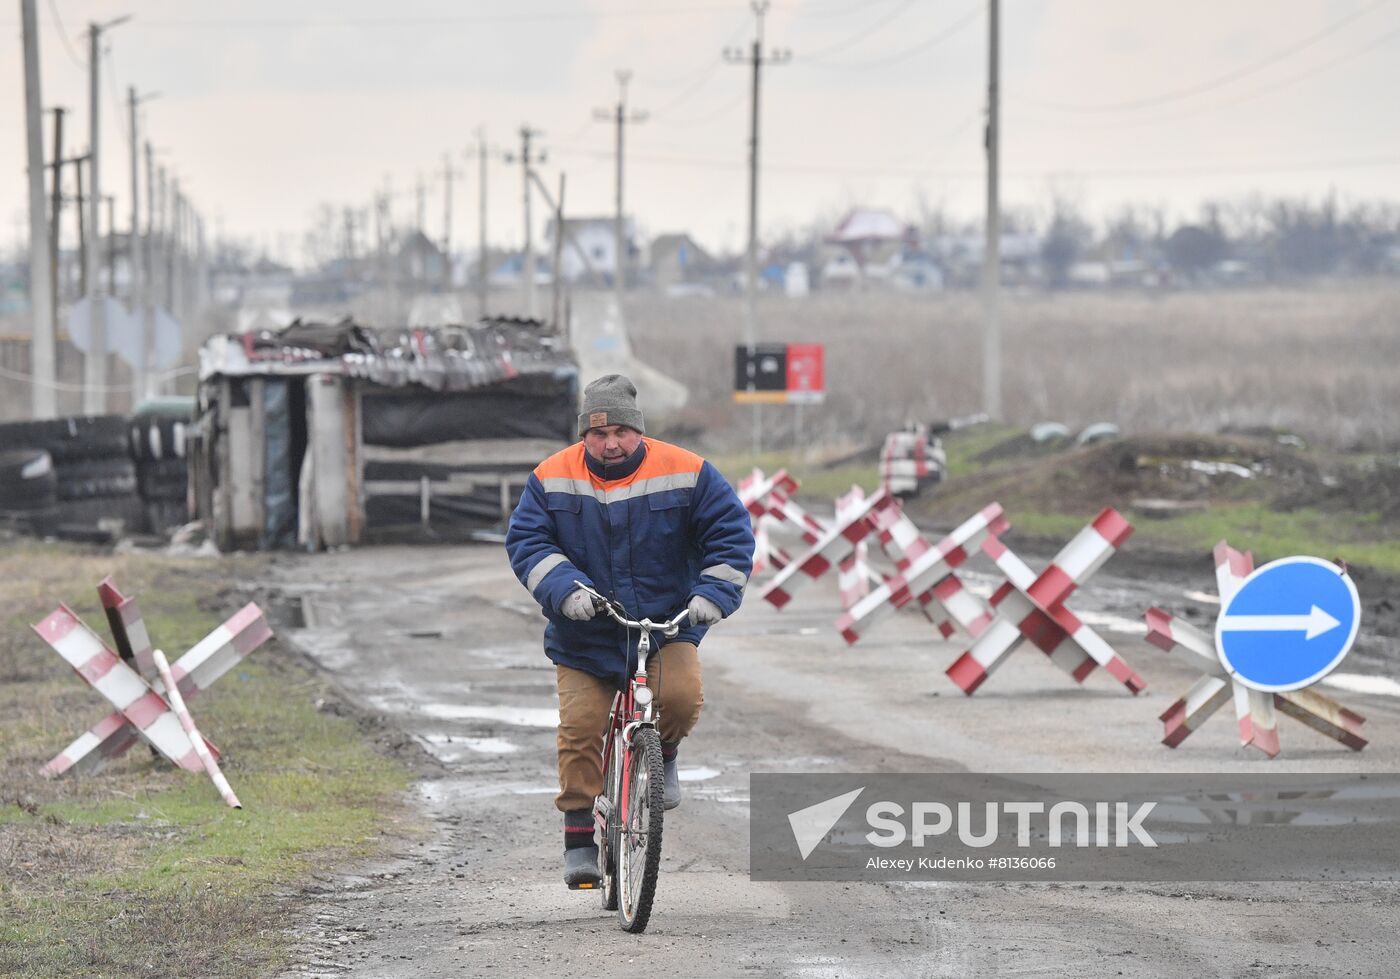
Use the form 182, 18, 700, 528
1145, 541, 1368, 758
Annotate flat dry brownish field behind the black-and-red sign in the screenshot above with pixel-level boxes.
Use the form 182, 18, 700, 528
627, 280, 1400, 451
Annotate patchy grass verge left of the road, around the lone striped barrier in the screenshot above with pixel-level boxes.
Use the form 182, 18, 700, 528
0, 539, 412, 979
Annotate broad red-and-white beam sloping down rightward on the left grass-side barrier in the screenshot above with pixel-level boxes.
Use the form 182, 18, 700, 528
32, 605, 203, 775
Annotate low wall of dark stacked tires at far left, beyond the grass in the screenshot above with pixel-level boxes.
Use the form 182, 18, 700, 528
0, 415, 146, 536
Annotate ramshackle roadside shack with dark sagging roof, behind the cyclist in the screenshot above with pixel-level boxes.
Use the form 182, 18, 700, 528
189, 318, 578, 550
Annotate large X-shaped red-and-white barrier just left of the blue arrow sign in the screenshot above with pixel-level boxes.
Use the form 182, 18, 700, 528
948, 507, 1147, 696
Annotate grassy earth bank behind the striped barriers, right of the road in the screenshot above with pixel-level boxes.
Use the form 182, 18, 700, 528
713, 424, 1400, 577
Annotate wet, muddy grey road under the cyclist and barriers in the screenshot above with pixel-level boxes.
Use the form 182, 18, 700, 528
274, 546, 1400, 979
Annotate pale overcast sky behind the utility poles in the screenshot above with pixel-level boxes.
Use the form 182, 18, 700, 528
0, 0, 1400, 259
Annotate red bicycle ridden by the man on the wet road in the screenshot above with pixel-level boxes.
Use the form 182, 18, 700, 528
574, 581, 689, 933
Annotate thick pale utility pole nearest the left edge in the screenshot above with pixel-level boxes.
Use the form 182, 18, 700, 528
20, 0, 62, 419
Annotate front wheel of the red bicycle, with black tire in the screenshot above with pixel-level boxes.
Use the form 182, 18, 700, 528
617, 727, 666, 934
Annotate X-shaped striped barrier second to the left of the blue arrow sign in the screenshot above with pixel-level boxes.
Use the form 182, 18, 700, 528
836, 503, 1009, 644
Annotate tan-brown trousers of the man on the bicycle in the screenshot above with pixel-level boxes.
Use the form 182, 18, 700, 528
554, 643, 704, 812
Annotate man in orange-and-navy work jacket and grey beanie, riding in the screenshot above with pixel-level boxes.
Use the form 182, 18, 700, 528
505, 374, 753, 887
